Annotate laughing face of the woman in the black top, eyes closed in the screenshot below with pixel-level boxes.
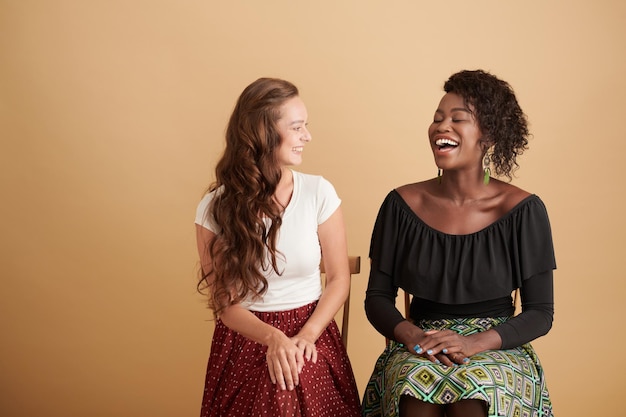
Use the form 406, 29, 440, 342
428, 93, 484, 171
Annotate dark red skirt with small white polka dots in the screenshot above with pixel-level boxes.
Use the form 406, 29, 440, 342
201, 303, 361, 417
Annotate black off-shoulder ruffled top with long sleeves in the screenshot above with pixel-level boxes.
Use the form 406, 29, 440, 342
365, 190, 556, 348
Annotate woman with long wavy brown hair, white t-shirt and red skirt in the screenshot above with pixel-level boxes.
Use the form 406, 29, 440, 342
195, 78, 361, 417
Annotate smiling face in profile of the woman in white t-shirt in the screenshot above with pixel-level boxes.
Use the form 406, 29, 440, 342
276, 96, 311, 167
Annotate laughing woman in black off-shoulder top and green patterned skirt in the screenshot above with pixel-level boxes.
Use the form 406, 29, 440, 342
363, 70, 556, 417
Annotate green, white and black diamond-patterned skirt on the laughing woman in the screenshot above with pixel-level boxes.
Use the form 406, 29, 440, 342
363, 317, 553, 417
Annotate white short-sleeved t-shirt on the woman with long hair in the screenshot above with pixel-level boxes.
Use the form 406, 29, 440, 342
195, 171, 341, 311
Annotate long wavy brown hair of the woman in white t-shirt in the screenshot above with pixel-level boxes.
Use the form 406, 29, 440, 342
198, 78, 298, 315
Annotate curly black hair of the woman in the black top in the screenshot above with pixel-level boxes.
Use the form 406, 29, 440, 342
443, 70, 529, 180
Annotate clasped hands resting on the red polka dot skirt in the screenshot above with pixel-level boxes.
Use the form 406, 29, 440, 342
266, 332, 317, 391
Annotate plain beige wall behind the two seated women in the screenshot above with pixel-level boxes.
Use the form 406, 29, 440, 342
0, 0, 626, 417
